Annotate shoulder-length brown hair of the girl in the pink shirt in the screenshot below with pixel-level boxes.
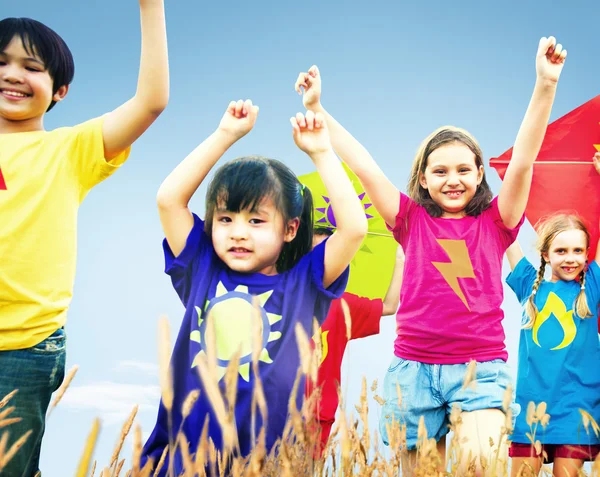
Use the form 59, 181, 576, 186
408, 126, 492, 217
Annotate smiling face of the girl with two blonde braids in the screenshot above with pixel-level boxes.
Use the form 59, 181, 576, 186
542, 228, 588, 282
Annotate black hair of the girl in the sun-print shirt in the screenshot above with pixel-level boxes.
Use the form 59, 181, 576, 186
204, 156, 313, 273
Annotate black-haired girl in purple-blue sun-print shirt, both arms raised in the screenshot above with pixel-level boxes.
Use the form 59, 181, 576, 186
143, 100, 367, 475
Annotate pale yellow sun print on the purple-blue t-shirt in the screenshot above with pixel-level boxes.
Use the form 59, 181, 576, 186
190, 282, 281, 382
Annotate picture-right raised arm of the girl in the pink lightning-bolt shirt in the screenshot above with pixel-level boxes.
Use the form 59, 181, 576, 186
498, 37, 567, 228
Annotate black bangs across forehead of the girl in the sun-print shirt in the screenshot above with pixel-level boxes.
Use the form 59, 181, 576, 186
206, 157, 281, 212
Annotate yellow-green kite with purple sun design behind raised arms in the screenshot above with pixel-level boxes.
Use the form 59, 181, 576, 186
299, 164, 398, 298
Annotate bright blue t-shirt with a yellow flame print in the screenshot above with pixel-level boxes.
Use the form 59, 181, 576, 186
506, 258, 600, 445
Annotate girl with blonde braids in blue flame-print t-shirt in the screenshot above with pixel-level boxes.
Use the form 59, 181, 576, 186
507, 154, 600, 476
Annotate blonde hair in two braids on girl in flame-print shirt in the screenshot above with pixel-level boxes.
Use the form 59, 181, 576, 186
523, 214, 593, 329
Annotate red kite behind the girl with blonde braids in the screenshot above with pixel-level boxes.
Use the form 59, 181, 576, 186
490, 96, 600, 259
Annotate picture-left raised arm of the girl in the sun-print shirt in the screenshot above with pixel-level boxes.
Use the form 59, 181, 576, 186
156, 100, 258, 256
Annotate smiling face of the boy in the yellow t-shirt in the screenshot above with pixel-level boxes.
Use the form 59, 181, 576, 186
0, 37, 68, 132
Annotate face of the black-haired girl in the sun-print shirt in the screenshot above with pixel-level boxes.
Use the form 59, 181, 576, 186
212, 197, 300, 275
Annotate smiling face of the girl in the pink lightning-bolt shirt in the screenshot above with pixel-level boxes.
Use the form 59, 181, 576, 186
419, 142, 483, 218
